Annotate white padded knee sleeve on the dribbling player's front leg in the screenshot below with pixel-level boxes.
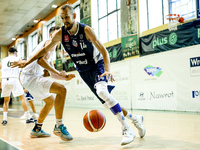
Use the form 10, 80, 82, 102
96, 82, 118, 108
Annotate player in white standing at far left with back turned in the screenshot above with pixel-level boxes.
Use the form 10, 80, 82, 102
0, 47, 34, 125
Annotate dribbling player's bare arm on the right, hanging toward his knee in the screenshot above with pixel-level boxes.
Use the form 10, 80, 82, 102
84, 26, 115, 82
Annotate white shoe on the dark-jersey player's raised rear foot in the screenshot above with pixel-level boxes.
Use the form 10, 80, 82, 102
133, 115, 146, 138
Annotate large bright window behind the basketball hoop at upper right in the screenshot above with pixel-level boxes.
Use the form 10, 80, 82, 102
138, 0, 198, 33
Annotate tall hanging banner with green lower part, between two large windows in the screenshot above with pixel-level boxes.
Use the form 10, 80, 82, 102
121, 0, 139, 58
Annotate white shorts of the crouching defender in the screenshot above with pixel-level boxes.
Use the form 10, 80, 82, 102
20, 73, 54, 100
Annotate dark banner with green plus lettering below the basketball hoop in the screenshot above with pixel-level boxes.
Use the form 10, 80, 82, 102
140, 20, 200, 55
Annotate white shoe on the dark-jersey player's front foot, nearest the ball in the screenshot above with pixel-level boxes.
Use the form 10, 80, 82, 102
121, 128, 136, 145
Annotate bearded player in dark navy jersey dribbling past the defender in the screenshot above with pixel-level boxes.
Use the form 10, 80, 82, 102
12, 4, 145, 145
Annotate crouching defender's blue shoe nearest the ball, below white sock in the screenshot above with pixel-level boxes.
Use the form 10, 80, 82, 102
53, 124, 73, 141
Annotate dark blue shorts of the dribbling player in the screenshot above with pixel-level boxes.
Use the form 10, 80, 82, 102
79, 60, 115, 104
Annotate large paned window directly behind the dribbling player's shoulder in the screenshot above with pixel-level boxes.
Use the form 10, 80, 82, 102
97, 0, 121, 43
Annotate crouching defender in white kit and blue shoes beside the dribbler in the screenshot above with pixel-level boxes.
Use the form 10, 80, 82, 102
20, 27, 75, 141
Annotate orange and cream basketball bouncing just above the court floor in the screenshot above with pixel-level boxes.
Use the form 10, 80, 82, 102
83, 110, 106, 132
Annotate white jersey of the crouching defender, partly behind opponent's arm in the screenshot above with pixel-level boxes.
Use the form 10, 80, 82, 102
22, 41, 51, 76
